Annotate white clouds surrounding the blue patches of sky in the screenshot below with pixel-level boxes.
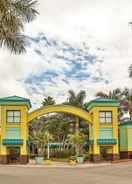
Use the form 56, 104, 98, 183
0, 0, 132, 108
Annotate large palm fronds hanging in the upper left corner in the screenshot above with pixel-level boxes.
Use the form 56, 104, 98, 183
0, 0, 38, 54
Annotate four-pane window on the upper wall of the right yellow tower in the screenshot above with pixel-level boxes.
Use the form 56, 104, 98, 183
99, 111, 112, 123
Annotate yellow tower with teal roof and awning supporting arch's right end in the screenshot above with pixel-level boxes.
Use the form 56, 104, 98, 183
85, 98, 119, 161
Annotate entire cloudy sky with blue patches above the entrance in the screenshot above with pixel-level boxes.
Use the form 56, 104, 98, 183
0, 0, 132, 108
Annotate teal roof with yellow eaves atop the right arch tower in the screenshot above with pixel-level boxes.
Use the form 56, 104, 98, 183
84, 98, 120, 111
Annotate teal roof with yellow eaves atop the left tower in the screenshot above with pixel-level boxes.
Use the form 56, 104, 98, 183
0, 96, 31, 109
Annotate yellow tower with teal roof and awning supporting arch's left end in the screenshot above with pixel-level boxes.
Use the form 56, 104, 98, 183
0, 96, 31, 164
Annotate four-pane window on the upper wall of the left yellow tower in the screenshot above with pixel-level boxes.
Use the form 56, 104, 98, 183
7, 111, 21, 123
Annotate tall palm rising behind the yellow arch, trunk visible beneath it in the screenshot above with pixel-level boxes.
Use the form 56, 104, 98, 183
64, 90, 86, 133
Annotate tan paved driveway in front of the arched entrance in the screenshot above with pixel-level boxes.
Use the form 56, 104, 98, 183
0, 162, 132, 184
